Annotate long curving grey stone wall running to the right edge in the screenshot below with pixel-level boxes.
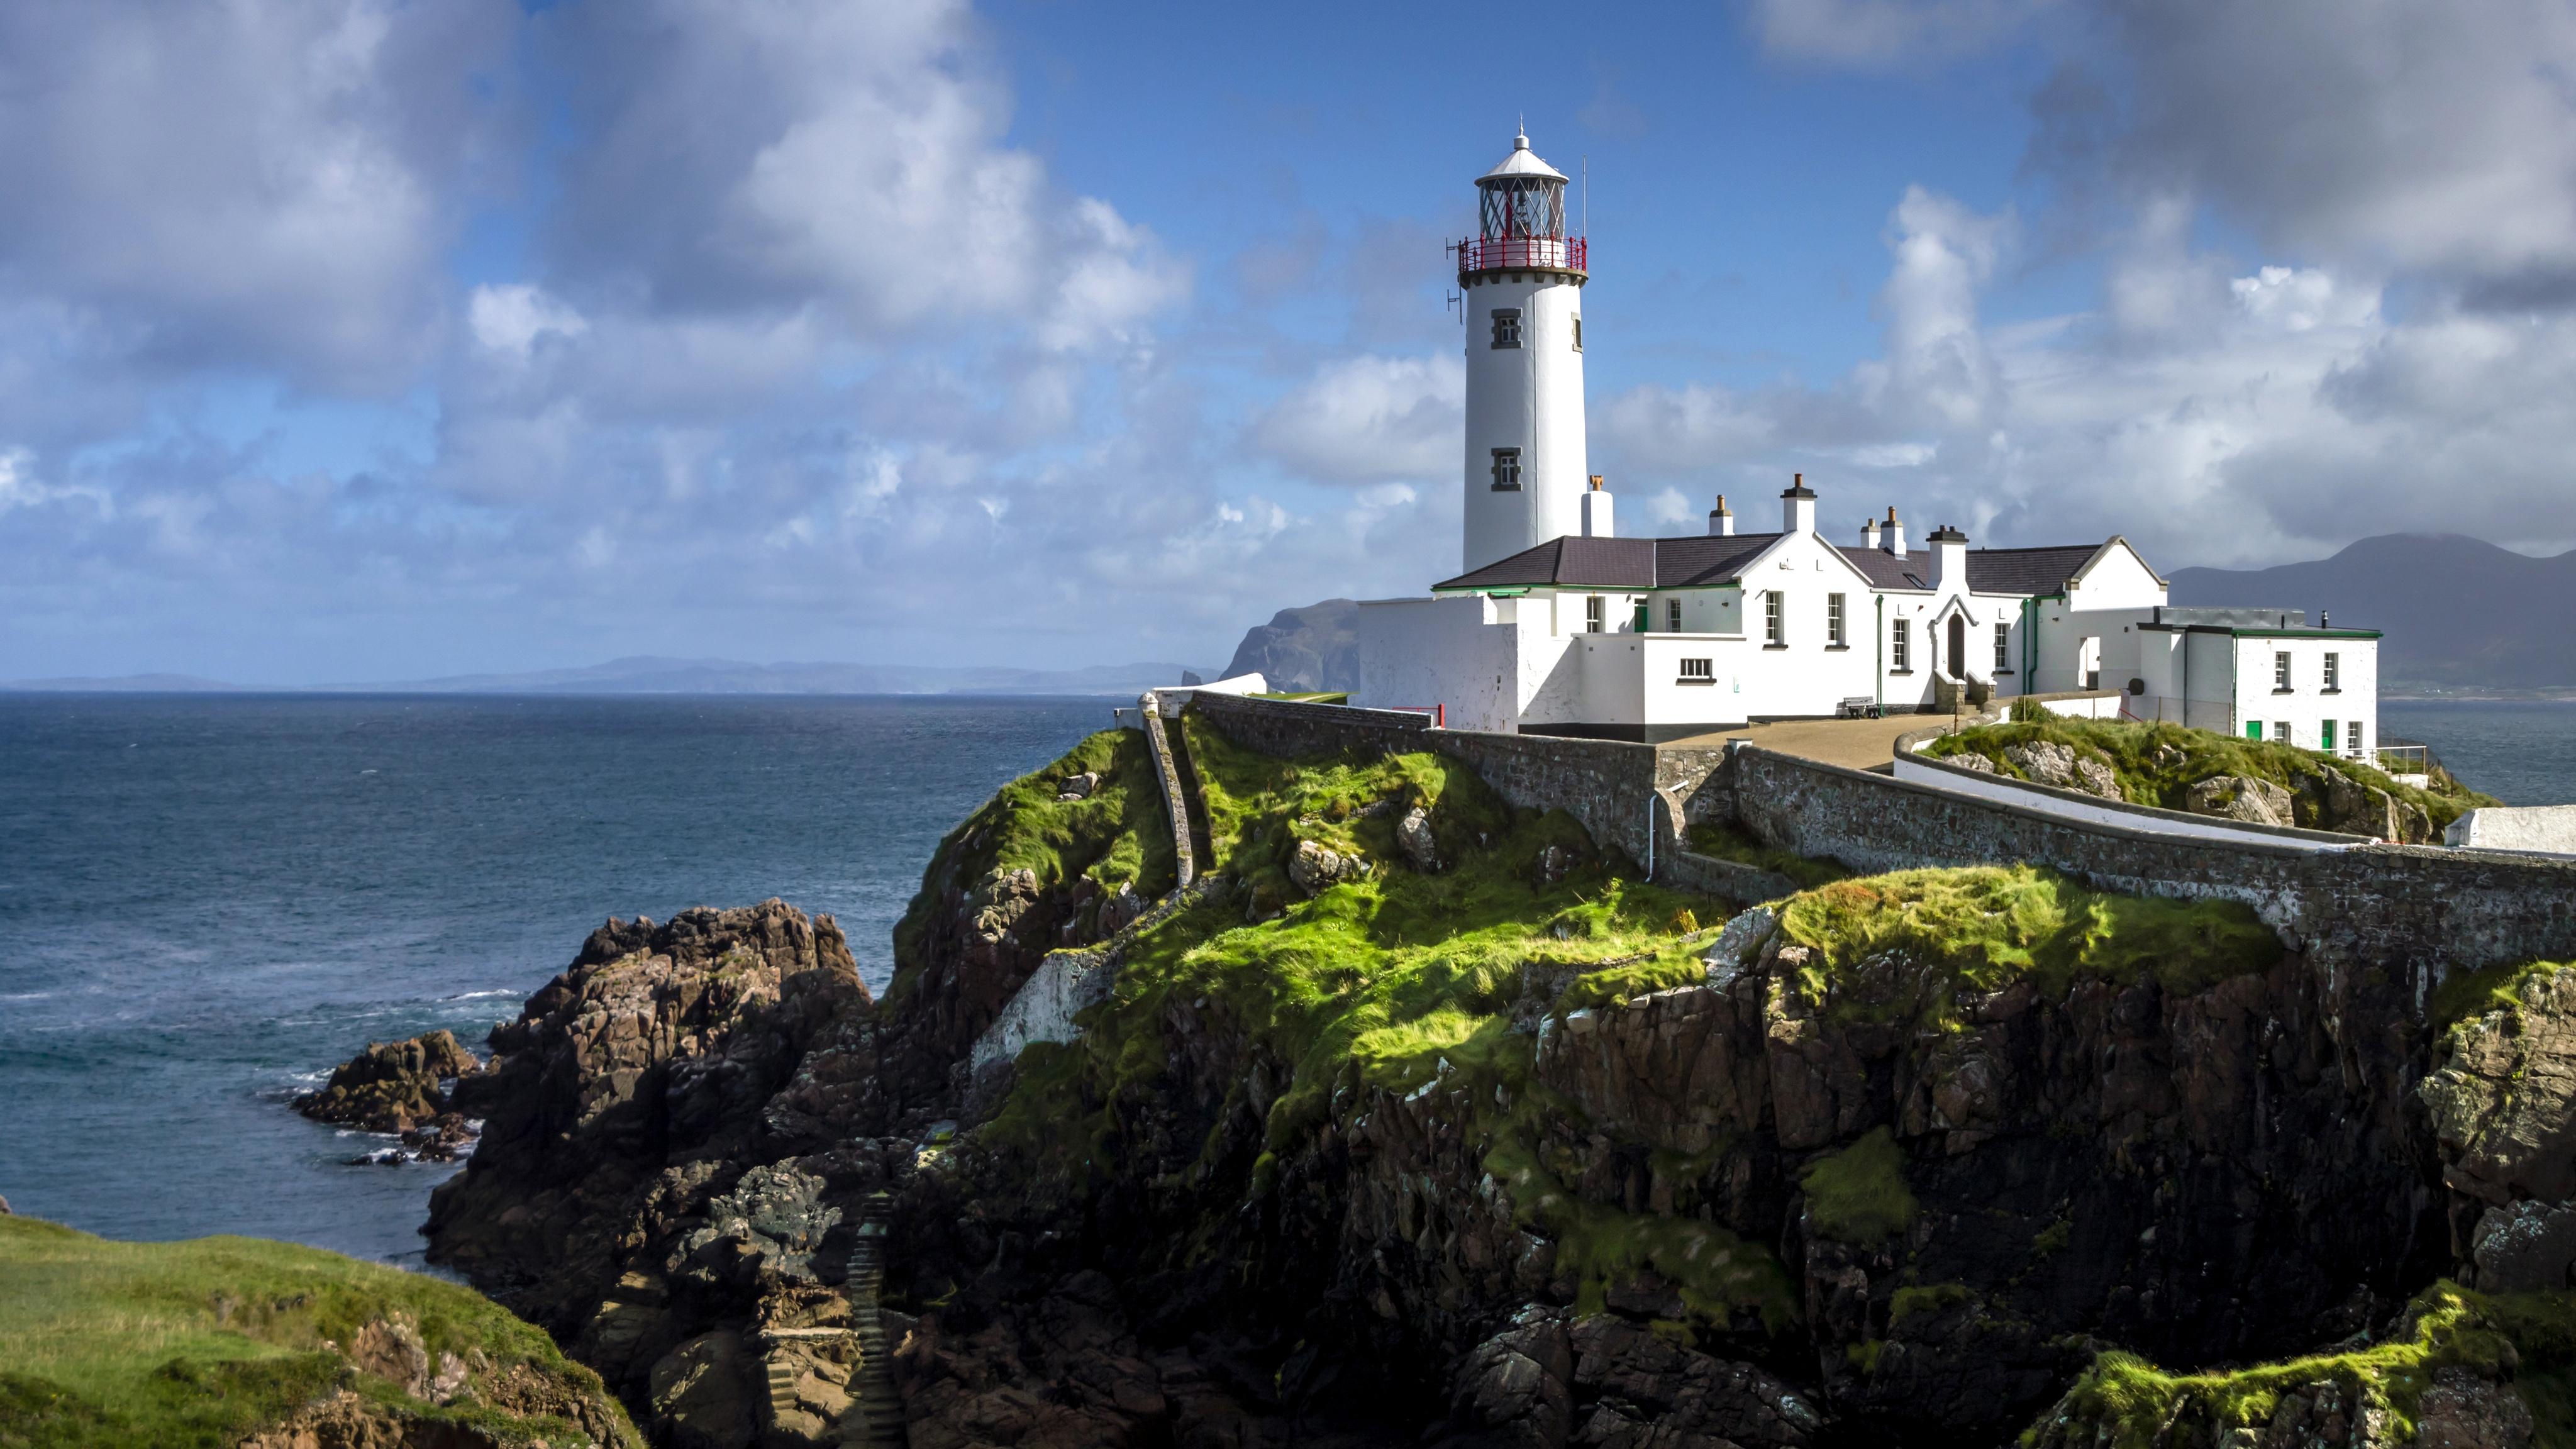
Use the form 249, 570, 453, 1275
1702, 748, 2576, 969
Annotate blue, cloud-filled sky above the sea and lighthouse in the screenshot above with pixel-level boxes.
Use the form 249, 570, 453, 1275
0, 0, 2576, 683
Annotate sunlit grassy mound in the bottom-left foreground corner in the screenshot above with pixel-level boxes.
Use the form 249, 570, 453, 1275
0, 1217, 641, 1449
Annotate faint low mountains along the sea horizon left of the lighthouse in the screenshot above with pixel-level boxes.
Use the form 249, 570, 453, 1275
0, 655, 1213, 694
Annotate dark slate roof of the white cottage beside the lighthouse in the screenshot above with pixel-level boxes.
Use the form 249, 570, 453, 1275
1432, 534, 2102, 593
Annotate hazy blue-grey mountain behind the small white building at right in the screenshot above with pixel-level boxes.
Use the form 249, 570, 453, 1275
2172, 534, 2576, 694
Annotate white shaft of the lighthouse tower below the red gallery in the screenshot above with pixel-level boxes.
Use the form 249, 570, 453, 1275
1460, 270, 1587, 572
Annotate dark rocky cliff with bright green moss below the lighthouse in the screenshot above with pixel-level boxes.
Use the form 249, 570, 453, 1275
407, 719, 2576, 1449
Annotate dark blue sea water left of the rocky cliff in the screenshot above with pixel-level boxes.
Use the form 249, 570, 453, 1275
0, 696, 1110, 1263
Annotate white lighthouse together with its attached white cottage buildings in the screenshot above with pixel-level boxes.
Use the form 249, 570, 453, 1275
1352, 136, 2378, 758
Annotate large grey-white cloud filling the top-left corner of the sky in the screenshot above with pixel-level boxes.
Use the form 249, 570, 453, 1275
0, 0, 508, 387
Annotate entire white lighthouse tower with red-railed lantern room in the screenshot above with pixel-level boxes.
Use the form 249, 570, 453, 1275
1458, 134, 1610, 570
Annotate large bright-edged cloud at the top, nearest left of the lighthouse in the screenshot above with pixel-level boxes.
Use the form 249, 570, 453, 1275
548, 0, 1187, 348
